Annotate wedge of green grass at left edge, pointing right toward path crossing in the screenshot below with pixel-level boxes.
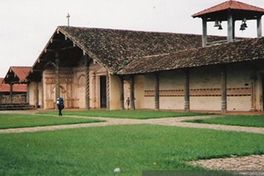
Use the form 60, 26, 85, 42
0, 114, 104, 129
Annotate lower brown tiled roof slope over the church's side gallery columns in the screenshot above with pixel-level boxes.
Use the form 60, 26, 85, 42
118, 38, 264, 74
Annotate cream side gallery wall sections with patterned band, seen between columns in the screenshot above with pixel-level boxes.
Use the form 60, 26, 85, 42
144, 64, 254, 111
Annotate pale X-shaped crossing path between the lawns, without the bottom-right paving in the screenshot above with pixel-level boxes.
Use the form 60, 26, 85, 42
0, 111, 264, 134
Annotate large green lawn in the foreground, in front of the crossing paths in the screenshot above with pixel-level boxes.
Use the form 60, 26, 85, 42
0, 125, 264, 176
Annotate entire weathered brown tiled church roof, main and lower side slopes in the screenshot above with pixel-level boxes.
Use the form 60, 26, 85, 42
29, 26, 264, 77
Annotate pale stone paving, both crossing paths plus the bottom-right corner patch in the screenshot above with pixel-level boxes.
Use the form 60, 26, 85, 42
0, 111, 264, 175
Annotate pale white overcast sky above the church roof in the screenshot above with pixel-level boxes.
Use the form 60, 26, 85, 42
0, 0, 264, 77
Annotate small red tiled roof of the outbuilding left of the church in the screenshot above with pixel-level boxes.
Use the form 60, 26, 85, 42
4, 66, 31, 83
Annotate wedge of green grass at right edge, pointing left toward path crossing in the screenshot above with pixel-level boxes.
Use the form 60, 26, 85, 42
186, 116, 264, 127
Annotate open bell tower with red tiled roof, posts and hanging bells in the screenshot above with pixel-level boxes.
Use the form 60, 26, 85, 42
192, 0, 264, 47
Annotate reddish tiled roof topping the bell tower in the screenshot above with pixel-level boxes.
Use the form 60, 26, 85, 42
192, 0, 264, 17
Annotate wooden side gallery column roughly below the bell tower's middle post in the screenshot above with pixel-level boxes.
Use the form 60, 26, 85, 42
221, 65, 227, 114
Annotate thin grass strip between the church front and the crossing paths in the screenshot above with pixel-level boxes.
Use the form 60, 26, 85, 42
39, 110, 208, 119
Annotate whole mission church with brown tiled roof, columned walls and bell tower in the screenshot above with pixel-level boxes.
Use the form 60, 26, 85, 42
5, 0, 264, 113
